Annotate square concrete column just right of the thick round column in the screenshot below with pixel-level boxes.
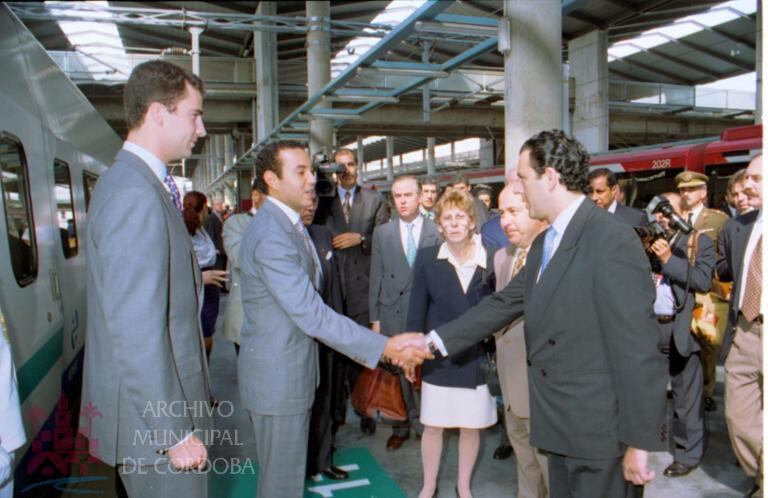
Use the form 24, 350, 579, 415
568, 30, 608, 152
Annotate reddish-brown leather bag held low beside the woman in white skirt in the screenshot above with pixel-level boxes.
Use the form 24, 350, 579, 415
352, 365, 408, 424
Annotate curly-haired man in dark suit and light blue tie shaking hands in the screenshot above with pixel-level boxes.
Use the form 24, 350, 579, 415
426, 130, 667, 498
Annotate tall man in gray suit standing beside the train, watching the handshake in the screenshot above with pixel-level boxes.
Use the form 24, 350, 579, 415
81, 61, 211, 498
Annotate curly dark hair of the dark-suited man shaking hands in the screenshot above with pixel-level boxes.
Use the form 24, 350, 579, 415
520, 130, 589, 193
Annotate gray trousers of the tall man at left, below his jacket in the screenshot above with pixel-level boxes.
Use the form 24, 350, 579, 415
117, 462, 208, 498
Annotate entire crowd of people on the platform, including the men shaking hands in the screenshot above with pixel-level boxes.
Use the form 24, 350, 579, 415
0, 61, 763, 498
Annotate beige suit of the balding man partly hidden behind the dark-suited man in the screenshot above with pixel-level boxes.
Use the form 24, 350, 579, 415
493, 246, 549, 498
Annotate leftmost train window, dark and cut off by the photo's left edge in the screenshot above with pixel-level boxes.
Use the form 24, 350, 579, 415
0, 132, 37, 287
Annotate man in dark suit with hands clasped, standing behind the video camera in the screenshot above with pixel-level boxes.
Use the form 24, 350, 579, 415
315, 149, 389, 434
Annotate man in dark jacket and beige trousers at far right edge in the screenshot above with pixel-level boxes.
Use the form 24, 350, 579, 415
717, 154, 764, 496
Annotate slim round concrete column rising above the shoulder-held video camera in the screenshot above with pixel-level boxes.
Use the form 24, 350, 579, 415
306, 0, 333, 154
